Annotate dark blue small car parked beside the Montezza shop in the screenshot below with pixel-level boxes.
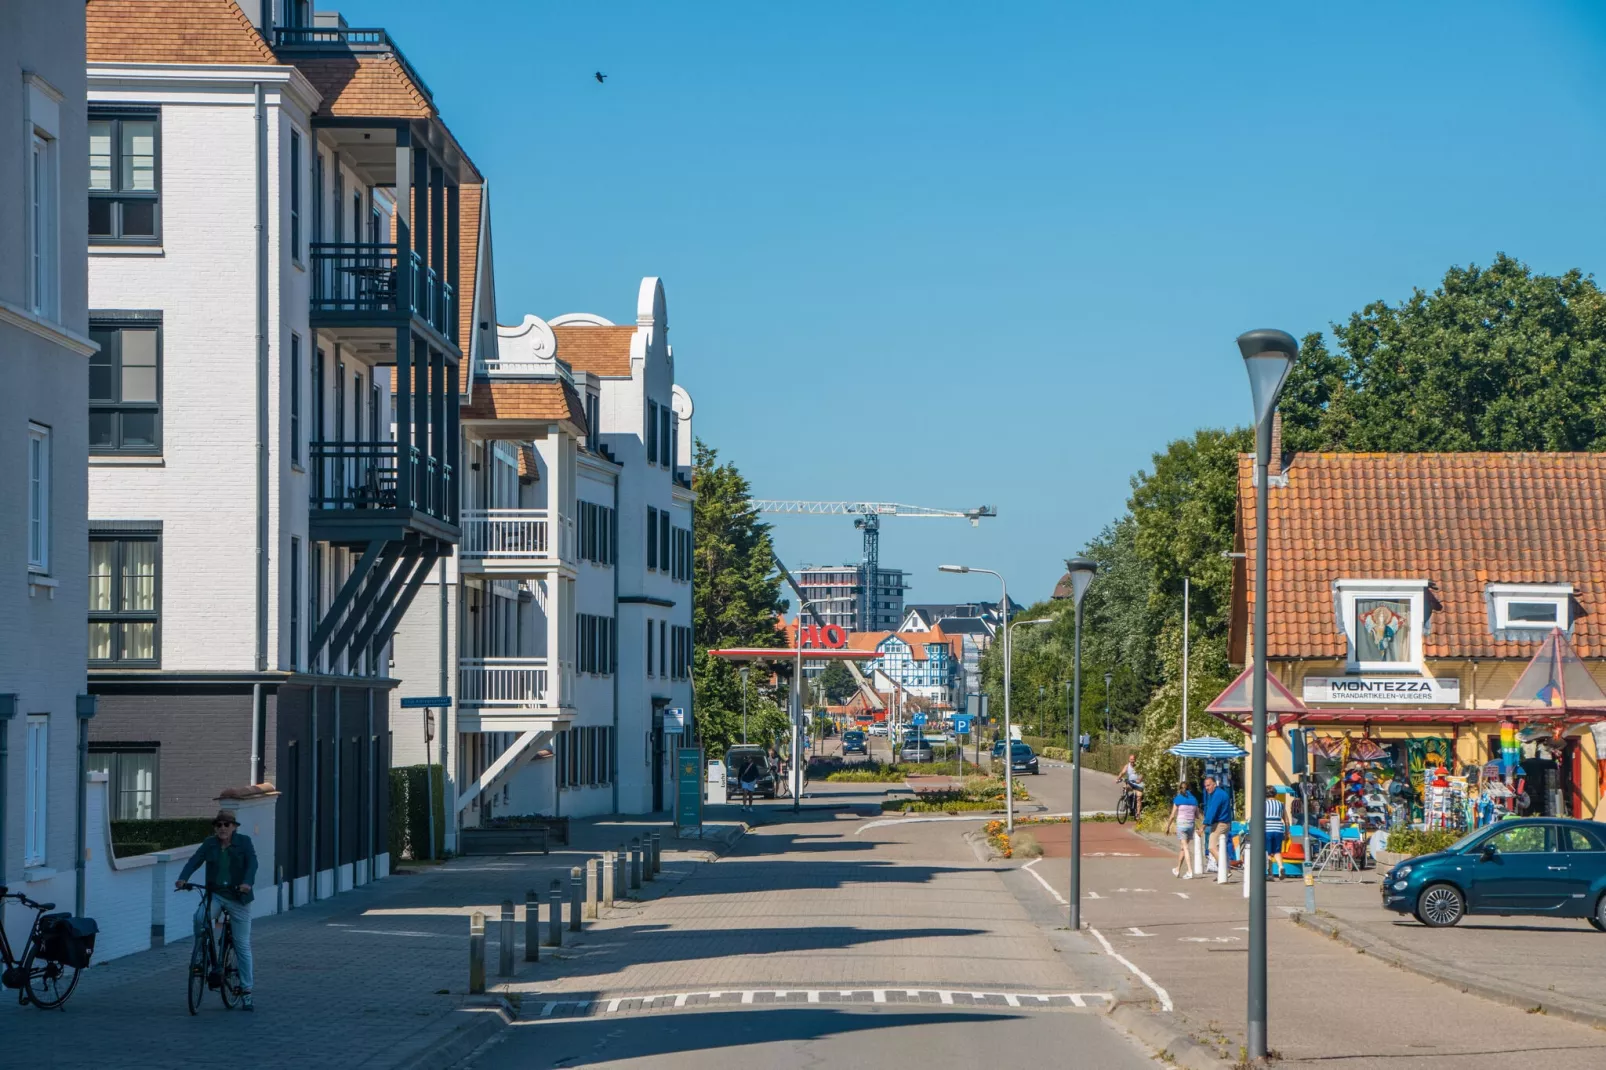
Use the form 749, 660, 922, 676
1383, 818, 1606, 932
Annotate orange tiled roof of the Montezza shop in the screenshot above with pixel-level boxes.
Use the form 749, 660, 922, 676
1230, 453, 1606, 664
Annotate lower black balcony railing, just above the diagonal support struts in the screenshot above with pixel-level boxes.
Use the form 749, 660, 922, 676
310, 442, 456, 524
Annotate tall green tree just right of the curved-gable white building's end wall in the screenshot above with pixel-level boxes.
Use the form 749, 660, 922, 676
692, 440, 787, 757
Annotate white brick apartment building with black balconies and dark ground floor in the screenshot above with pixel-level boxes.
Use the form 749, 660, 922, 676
83, 0, 468, 909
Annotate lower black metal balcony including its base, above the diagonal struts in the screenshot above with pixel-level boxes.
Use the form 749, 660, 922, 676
310, 442, 458, 543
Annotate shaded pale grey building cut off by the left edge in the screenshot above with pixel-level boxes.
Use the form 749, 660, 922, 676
0, 3, 95, 918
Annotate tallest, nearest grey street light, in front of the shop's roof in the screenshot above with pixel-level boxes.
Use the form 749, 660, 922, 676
1238, 329, 1299, 1064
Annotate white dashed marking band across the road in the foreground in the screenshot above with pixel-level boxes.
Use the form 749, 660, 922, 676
536, 988, 1115, 1019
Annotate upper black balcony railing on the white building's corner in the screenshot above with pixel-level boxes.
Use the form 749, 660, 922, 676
312, 241, 458, 341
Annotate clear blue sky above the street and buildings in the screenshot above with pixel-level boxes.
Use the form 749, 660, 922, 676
358, 0, 1606, 602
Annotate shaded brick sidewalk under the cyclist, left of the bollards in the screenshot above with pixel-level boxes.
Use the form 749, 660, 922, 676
0, 821, 735, 1070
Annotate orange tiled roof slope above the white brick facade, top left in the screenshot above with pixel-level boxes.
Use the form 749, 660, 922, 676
84, 0, 279, 66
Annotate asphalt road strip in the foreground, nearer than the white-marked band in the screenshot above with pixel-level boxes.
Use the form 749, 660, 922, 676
474, 1007, 1158, 1070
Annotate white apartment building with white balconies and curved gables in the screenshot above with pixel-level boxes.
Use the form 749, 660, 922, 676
390, 273, 694, 822
